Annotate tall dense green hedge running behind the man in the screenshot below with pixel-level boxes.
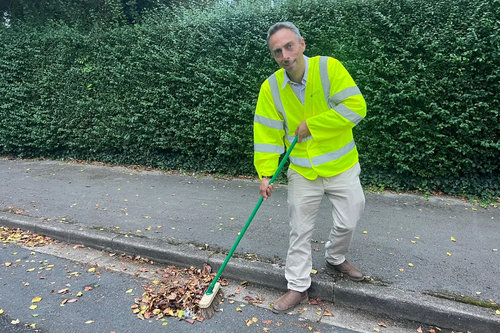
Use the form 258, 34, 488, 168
0, 0, 500, 198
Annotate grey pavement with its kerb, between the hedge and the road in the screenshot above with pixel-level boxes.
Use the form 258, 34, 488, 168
0, 159, 500, 332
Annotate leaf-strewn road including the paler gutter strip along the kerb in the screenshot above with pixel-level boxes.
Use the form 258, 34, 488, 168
0, 239, 449, 333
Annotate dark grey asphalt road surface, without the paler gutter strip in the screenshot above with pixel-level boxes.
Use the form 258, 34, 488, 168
0, 244, 354, 333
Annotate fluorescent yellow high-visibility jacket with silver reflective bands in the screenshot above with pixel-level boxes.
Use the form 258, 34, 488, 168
254, 57, 366, 180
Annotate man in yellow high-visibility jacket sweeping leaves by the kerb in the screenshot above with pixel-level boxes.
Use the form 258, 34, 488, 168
254, 22, 366, 313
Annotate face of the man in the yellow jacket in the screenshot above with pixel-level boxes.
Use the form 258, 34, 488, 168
269, 28, 306, 73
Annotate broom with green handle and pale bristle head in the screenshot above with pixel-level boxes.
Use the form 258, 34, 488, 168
198, 136, 298, 319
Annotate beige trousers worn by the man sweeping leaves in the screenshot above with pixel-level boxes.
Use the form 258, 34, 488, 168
285, 163, 365, 292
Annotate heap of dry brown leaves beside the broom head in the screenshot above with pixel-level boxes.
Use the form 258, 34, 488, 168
132, 264, 227, 323
